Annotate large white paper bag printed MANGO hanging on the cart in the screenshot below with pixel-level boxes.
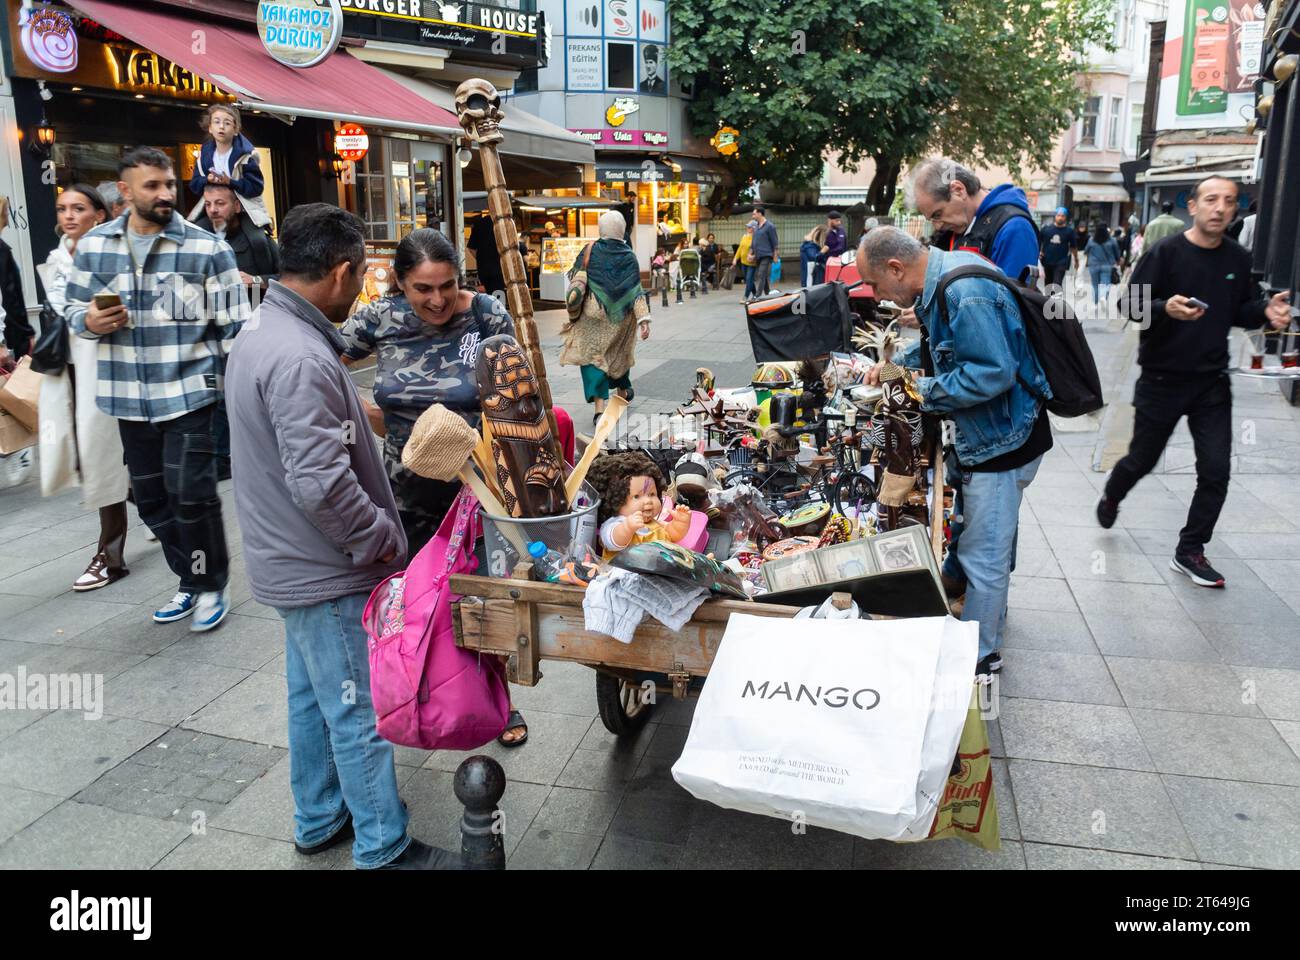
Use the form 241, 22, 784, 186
672, 614, 979, 839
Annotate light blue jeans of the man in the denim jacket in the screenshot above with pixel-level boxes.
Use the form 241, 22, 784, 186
958, 457, 1043, 660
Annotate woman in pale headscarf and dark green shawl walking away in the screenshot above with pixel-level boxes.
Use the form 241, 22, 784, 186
560, 211, 650, 423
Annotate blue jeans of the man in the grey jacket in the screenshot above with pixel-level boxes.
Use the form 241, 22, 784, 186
277, 593, 411, 870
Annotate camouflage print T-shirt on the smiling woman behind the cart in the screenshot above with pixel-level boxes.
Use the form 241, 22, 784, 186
342, 287, 515, 457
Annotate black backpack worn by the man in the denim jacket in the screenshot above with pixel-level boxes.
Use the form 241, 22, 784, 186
935, 264, 1105, 416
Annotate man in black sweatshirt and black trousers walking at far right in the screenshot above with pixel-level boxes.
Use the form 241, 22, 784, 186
1097, 177, 1291, 587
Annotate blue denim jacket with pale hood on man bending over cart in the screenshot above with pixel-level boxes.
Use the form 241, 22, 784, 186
898, 248, 1052, 466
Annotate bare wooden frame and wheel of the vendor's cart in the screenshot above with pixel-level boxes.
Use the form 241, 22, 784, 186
451, 442, 944, 736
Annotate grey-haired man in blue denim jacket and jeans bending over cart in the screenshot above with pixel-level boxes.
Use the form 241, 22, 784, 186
858, 226, 1052, 680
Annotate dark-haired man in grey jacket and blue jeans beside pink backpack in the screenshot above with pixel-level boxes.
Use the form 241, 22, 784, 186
226, 203, 459, 870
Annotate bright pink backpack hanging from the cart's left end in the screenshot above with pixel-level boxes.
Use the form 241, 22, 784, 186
361, 489, 510, 751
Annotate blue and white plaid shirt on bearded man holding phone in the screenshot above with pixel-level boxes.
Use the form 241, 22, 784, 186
64, 212, 250, 423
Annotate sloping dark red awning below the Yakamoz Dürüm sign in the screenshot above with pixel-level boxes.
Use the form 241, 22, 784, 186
68, 0, 462, 134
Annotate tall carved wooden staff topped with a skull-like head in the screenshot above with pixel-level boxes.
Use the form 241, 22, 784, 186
456, 79, 560, 437
